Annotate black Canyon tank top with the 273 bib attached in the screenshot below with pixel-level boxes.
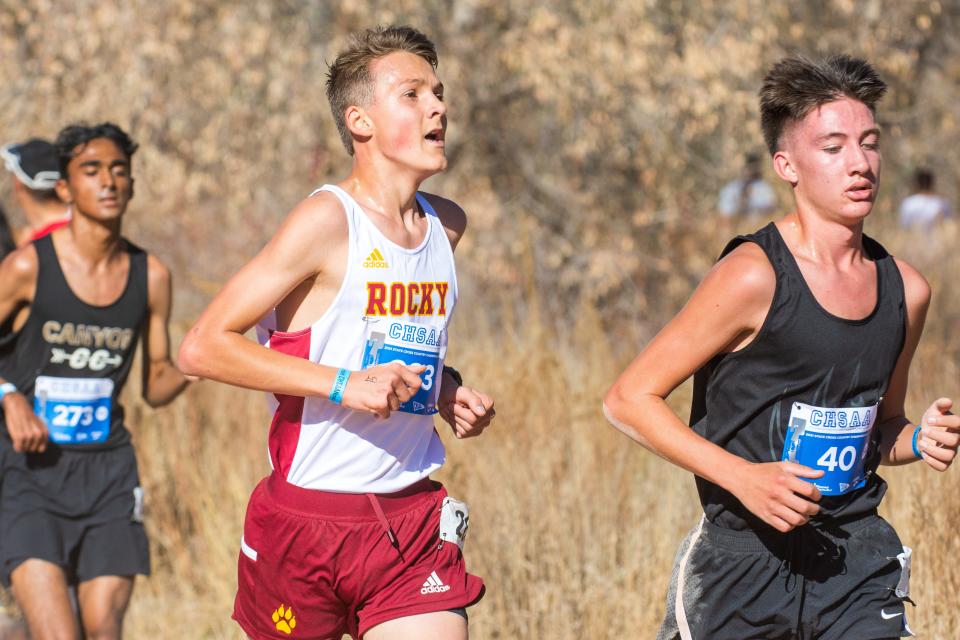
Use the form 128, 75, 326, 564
0, 235, 148, 450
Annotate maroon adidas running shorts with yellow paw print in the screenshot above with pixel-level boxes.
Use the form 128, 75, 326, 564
233, 474, 484, 640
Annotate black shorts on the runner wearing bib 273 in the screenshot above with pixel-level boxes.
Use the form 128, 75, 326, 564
0, 442, 150, 587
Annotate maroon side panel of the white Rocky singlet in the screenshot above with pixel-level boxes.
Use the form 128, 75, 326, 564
267, 327, 312, 478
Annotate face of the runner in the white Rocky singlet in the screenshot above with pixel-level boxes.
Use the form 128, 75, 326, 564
366, 51, 447, 176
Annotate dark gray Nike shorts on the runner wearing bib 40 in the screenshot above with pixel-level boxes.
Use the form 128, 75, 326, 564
657, 515, 913, 640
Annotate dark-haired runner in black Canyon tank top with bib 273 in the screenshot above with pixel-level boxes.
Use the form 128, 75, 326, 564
0, 123, 187, 638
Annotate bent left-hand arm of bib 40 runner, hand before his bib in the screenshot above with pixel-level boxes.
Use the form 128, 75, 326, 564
604, 243, 822, 531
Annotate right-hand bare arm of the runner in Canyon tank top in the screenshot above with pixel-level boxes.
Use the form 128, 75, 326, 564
143, 255, 188, 407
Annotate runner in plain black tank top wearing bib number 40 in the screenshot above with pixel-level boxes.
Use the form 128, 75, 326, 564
604, 56, 960, 640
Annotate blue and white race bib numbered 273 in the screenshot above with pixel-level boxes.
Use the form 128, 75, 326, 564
33, 376, 113, 444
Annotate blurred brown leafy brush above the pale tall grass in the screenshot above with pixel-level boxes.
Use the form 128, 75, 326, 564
0, 0, 960, 322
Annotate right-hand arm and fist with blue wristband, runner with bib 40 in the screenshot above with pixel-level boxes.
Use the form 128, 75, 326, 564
878, 260, 960, 471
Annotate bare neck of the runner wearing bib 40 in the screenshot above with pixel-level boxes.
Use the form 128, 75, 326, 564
778, 211, 863, 265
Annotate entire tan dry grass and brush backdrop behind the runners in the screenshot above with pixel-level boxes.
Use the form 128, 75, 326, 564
0, 0, 960, 640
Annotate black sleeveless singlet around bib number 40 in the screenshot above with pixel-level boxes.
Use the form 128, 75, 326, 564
690, 223, 906, 530
